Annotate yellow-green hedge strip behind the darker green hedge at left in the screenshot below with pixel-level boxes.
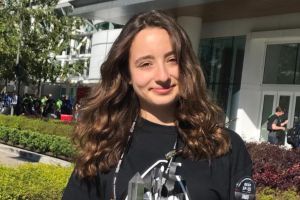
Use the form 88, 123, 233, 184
0, 115, 74, 137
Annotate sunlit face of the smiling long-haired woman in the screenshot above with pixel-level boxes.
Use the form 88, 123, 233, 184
129, 28, 179, 109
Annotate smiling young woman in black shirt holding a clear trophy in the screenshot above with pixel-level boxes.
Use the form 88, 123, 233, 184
63, 11, 252, 200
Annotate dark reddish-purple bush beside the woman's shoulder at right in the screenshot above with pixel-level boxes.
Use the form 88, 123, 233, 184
247, 143, 300, 192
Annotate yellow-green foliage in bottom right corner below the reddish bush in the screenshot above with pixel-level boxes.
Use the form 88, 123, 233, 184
256, 187, 300, 200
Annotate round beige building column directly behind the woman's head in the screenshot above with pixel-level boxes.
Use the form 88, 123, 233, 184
177, 16, 202, 56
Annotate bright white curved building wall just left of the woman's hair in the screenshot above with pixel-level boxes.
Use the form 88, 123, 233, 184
88, 29, 122, 80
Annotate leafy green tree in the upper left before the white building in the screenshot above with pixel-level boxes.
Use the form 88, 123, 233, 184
0, 0, 83, 93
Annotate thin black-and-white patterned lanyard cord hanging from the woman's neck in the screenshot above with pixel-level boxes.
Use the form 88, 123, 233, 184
111, 116, 178, 200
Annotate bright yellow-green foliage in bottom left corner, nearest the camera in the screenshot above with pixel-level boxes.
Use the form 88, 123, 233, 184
0, 164, 73, 200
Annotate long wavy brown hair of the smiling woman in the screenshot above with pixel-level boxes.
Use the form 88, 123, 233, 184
73, 10, 230, 178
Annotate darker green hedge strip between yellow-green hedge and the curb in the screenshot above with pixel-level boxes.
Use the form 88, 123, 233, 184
0, 126, 75, 160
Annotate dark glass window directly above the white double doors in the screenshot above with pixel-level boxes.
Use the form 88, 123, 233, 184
263, 44, 300, 84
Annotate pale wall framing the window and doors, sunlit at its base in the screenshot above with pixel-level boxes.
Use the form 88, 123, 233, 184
235, 29, 300, 141
